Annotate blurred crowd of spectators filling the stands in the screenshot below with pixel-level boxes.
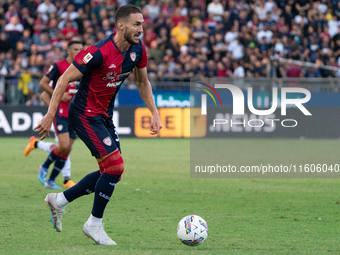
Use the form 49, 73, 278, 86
0, 0, 340, 105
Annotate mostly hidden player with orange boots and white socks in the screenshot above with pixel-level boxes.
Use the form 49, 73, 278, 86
24, 91, 75, 188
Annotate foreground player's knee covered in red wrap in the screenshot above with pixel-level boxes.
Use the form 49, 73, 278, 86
99, 150, 124, 175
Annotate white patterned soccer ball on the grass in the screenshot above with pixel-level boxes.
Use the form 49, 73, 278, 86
177, 215, 208, 246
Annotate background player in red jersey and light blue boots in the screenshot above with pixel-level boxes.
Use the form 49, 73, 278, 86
38, 41, 83, 189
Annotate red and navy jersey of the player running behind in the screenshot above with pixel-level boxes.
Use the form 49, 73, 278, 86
46, 60, 77, 117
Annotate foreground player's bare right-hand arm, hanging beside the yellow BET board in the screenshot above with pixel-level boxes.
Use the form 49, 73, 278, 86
133, 67, 162, 135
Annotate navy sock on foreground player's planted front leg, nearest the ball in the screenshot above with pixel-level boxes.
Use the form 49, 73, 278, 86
92, 172, 120, 218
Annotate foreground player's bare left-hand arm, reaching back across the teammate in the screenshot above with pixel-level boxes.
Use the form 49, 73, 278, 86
34, 64, 83, 140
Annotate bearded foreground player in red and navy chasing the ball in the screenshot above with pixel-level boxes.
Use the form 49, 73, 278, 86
35, 4, 162, 245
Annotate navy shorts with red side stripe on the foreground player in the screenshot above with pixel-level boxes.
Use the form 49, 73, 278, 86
69, 111, 120, 158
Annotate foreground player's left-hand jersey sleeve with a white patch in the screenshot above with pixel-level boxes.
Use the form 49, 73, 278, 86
72, 45, 103, 75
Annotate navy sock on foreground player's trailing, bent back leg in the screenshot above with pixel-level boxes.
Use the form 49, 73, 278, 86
63, 170, 100, 202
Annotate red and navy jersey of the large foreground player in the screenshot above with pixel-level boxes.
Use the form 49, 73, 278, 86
72, 34, 148, 117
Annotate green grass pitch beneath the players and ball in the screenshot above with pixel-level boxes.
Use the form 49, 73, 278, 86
0, 138, 340, 255
